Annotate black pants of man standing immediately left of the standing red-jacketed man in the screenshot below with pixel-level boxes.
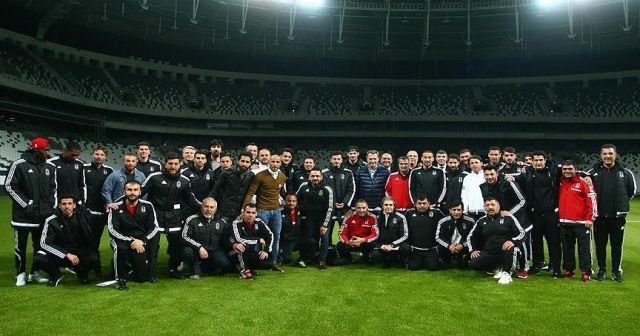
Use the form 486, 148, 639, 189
529, 212, 562, 272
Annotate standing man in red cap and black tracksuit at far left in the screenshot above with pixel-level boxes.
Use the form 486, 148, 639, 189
5, 138, 57, 286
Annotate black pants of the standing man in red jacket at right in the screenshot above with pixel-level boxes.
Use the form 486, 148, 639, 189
560, 225, 591, 275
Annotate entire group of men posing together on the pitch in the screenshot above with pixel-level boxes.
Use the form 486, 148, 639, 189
5, 138, 636, 290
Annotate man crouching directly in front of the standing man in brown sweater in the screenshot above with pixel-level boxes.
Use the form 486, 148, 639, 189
231, 203, 273, 280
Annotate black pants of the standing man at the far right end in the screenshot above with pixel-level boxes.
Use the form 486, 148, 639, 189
593, 217, 627, 273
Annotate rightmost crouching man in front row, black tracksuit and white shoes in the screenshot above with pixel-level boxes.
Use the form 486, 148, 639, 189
467, 197, 525, 285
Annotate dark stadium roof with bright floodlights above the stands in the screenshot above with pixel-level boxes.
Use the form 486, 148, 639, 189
3, 0, 640, 60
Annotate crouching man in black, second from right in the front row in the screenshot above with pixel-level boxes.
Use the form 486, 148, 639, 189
436, 200, 475, 268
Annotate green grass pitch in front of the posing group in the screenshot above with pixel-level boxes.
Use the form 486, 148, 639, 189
0, 197, 640, 335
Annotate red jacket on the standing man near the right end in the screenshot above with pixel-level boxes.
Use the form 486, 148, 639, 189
558, 176, 598, 224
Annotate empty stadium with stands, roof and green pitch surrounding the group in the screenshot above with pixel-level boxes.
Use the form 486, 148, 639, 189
0, 0, 640, 335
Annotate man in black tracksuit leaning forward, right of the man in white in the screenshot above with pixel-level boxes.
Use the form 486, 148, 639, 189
480, 165, 531, 279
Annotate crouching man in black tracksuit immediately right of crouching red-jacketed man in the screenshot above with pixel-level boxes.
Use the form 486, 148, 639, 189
371, 196, 409, 267
